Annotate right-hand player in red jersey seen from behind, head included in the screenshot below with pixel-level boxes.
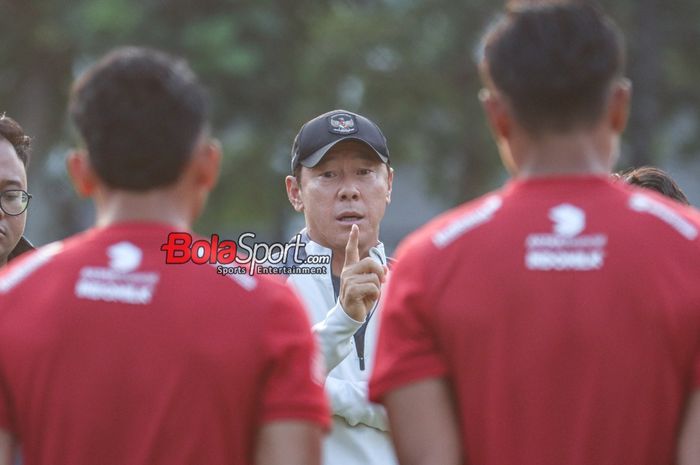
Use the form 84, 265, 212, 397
370, 1, 700, 465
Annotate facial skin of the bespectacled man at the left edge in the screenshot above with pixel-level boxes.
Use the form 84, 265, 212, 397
0, 136, 27, 266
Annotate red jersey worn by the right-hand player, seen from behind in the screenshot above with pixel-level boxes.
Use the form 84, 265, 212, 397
370, 177, 700, 465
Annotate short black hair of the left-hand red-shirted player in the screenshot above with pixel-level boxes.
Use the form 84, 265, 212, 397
69, 47, 209, 191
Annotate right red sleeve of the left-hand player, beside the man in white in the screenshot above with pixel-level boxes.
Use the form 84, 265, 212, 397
261, 284, 330, 428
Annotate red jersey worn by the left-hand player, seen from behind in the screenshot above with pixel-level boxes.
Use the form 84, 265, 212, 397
0, 223, 329, 465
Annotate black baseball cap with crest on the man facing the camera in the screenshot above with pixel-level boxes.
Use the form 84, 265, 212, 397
292, 110, 389, 172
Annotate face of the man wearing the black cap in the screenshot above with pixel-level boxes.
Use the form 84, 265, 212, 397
292, 141, 393, 253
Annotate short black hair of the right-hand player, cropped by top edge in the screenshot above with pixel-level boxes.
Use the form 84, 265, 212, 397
479, 0, 625, 134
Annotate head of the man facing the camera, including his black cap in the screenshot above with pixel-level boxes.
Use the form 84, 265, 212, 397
286, 110, 393, 260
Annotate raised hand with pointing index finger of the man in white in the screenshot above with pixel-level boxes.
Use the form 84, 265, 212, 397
339, 224, 386, 321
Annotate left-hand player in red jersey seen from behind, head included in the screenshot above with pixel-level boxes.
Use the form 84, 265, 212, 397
0, 48, 328, 465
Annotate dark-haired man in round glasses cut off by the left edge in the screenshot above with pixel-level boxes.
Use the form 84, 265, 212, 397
0, 114, 34, 267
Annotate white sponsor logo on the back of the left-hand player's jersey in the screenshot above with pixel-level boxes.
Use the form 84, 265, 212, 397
75, 241, 160, 305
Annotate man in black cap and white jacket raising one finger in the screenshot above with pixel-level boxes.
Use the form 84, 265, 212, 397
286, 110, 397, 465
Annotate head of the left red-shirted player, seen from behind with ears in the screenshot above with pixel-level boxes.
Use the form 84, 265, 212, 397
69, 47, 219, 227
